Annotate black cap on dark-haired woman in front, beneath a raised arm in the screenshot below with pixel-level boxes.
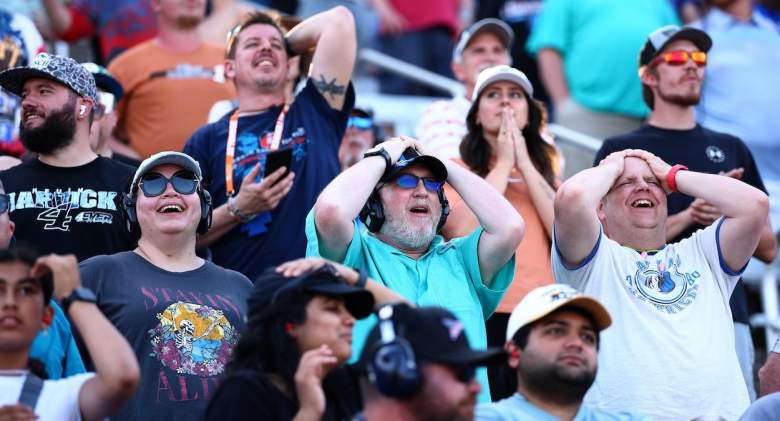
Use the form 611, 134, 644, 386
248, 264, 374, 319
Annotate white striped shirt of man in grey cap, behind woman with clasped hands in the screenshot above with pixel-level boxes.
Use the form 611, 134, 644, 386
417, 96, 471, 159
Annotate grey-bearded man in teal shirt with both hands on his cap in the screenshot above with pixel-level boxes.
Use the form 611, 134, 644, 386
306, 138, 524, 400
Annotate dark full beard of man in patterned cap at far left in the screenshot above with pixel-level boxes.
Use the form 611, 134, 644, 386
19, 100, 76, 155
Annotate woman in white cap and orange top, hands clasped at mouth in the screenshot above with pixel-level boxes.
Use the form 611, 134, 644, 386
442, 65, 559, 399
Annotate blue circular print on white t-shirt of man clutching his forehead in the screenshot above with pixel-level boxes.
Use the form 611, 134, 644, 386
625, 250, 701, 314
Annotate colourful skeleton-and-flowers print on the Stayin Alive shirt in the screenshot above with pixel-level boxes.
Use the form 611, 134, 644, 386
149, 301, 238, 377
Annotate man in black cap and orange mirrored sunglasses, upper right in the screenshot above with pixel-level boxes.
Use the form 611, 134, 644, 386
594, 25, 777, 398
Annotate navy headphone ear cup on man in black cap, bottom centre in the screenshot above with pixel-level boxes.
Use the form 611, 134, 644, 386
367, 337, 420, 399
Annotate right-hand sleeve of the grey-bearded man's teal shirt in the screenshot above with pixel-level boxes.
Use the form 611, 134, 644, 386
452, 227, 515, 319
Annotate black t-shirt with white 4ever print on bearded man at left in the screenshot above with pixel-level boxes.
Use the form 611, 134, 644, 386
0, 157, 134, 261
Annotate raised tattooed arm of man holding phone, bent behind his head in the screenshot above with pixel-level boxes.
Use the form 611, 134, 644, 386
287, 6, 357, 109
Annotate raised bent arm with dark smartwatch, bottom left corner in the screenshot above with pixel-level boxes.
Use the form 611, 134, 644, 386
31, 254, 140, 420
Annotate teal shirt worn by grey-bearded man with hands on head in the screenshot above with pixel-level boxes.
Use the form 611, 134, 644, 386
306, 210, 515, 402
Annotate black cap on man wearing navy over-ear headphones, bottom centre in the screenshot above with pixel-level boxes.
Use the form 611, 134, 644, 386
358, 303, 506, 367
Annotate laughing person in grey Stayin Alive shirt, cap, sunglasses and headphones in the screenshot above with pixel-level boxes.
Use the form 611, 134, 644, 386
81, 152, 252, 420
